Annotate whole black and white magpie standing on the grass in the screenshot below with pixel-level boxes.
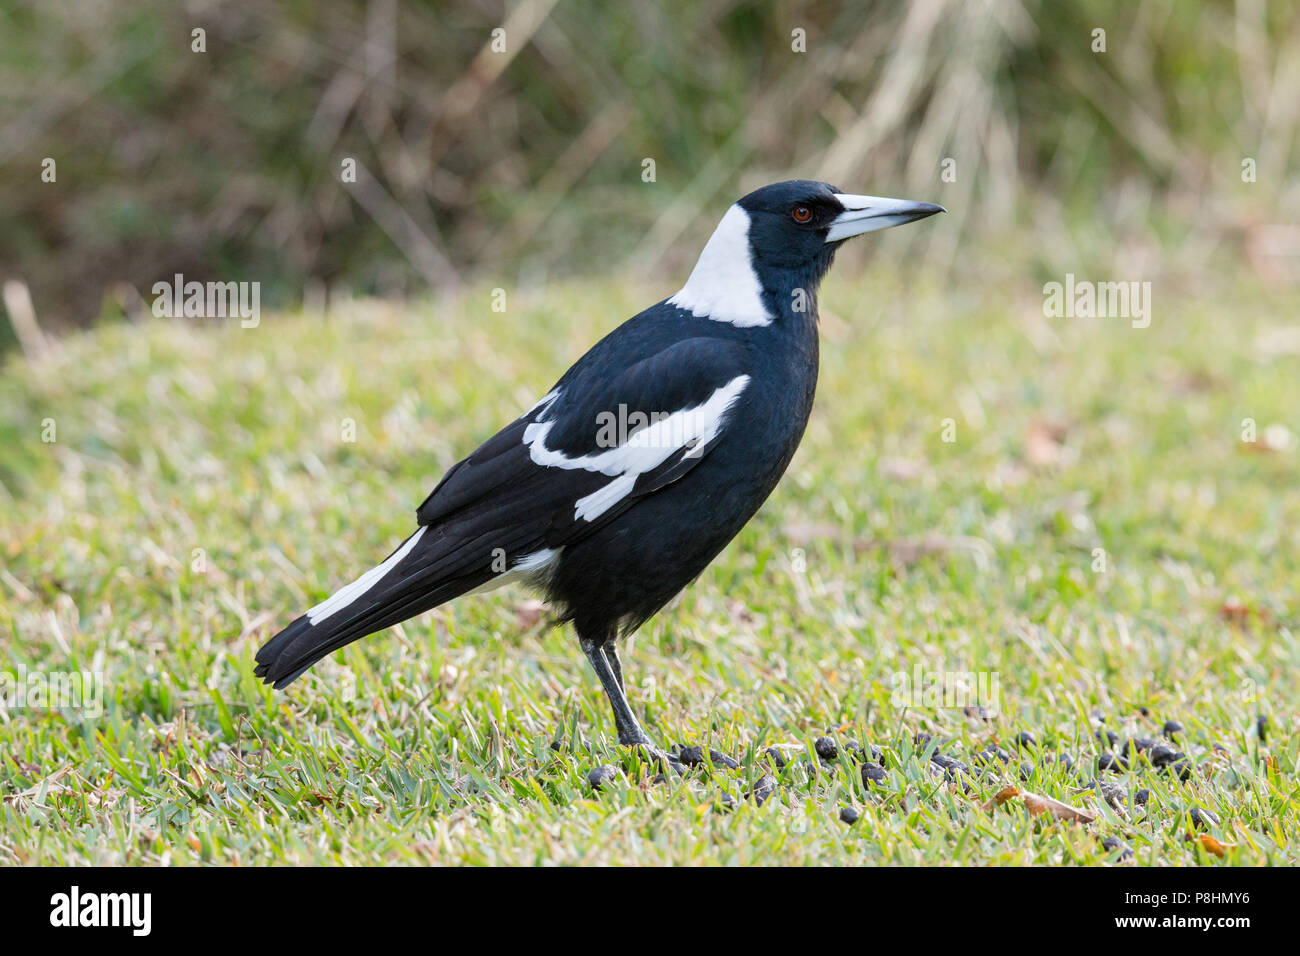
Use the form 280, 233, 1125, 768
255, 179, 944, 750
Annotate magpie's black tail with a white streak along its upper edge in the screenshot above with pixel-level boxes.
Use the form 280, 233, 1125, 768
254, 527, 506, 689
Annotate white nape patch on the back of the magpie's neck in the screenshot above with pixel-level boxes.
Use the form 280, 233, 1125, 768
668, 206, 772, 326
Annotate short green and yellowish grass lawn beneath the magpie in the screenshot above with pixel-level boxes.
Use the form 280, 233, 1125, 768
0, 267, 1300, 865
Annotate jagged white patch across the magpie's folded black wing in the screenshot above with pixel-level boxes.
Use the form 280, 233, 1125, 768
524, 375, 749, 522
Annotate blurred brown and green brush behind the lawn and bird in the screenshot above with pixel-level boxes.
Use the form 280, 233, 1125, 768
0, 0, 1300, 340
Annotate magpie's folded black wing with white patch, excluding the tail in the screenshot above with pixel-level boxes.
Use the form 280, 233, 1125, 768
416, 338, 750, 548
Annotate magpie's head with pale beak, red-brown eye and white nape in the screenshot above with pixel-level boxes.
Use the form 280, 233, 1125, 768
668, 179, 945, 325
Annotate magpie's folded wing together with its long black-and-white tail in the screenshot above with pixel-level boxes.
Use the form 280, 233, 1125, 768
254, 338, 750, 688
